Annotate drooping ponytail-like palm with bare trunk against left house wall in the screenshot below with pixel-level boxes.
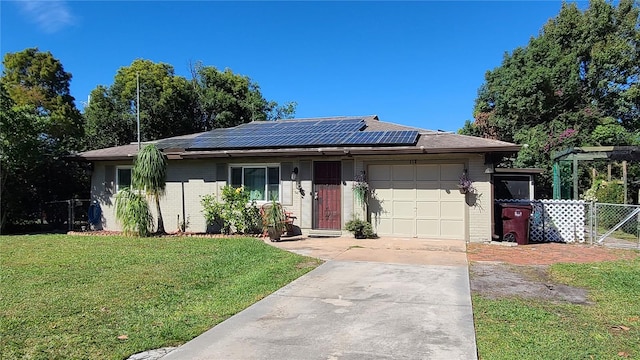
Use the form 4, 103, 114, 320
131, 144, 167, 234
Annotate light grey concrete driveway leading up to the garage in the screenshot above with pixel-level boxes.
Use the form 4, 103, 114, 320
162, 238, 477, 360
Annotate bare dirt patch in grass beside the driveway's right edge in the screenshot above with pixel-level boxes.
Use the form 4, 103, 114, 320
469, 262, 589, 304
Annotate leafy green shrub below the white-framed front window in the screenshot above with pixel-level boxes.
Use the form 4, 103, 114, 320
200, 185, 262, 234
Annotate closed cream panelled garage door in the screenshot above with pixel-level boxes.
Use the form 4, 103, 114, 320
368, 164, 466, 239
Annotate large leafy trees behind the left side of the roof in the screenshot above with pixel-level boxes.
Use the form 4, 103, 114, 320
85, 59, 296, 149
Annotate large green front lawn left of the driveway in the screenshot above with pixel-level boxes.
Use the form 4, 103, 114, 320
0, 235, 318, 359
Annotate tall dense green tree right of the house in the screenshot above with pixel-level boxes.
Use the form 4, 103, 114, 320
460, 0, 640, 197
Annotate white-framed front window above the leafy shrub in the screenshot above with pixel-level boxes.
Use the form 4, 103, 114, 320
229, 165, 280, 201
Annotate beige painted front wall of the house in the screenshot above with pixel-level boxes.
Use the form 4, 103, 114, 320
87, 154, 492, 242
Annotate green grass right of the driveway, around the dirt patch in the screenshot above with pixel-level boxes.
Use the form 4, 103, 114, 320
473, 259, 640, 359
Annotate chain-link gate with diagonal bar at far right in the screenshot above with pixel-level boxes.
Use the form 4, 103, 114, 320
587, 203, 640, 248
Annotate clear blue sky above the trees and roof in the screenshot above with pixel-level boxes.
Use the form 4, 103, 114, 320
0, 1, 586, 131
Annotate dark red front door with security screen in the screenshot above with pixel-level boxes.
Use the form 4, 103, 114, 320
313, 161, 342, 230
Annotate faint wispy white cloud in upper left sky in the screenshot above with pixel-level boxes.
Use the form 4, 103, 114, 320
18, 0, 74, 33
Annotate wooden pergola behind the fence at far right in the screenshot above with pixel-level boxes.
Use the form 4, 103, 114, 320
551, 146, 640, 204
